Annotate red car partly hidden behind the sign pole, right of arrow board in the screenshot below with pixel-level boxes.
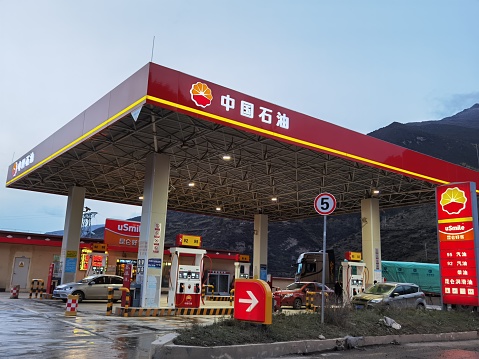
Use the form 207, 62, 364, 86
273, 282, 334, 310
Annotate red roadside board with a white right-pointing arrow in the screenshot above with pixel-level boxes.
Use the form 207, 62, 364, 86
234, 279, 273, 324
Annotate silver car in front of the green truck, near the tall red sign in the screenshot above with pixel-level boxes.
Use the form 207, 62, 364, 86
351, 282, 426, 309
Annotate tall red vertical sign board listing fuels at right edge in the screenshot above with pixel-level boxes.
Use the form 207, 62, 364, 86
436, 182, 479, 306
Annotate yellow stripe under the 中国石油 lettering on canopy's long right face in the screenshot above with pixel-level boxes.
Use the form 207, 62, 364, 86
146, 95, 450, 186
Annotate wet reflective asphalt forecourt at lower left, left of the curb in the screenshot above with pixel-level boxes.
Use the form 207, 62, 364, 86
0, 292, 221, 359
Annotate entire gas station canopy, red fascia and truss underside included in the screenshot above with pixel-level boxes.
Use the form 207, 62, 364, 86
6, 63, 479, 221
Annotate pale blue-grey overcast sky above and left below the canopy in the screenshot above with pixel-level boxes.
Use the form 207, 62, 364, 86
0, 0, 479, 233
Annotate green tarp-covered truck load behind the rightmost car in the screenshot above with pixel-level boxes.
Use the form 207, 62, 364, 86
381, 261, 441, 295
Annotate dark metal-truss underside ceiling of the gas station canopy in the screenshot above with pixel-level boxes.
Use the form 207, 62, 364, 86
10, 104, 436, 221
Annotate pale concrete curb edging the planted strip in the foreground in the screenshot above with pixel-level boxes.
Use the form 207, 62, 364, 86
150, 331, 478, 359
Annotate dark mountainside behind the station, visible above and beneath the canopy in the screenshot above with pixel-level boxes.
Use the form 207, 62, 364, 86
52, 104, 479, 277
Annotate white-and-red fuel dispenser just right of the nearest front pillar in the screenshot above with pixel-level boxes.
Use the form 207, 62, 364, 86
168, 235, 206, 308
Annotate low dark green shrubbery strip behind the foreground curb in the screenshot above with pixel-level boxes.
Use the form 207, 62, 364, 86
174, 307, 479, 346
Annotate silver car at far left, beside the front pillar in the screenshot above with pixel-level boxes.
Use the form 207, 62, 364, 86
52, 274, 123, 302
